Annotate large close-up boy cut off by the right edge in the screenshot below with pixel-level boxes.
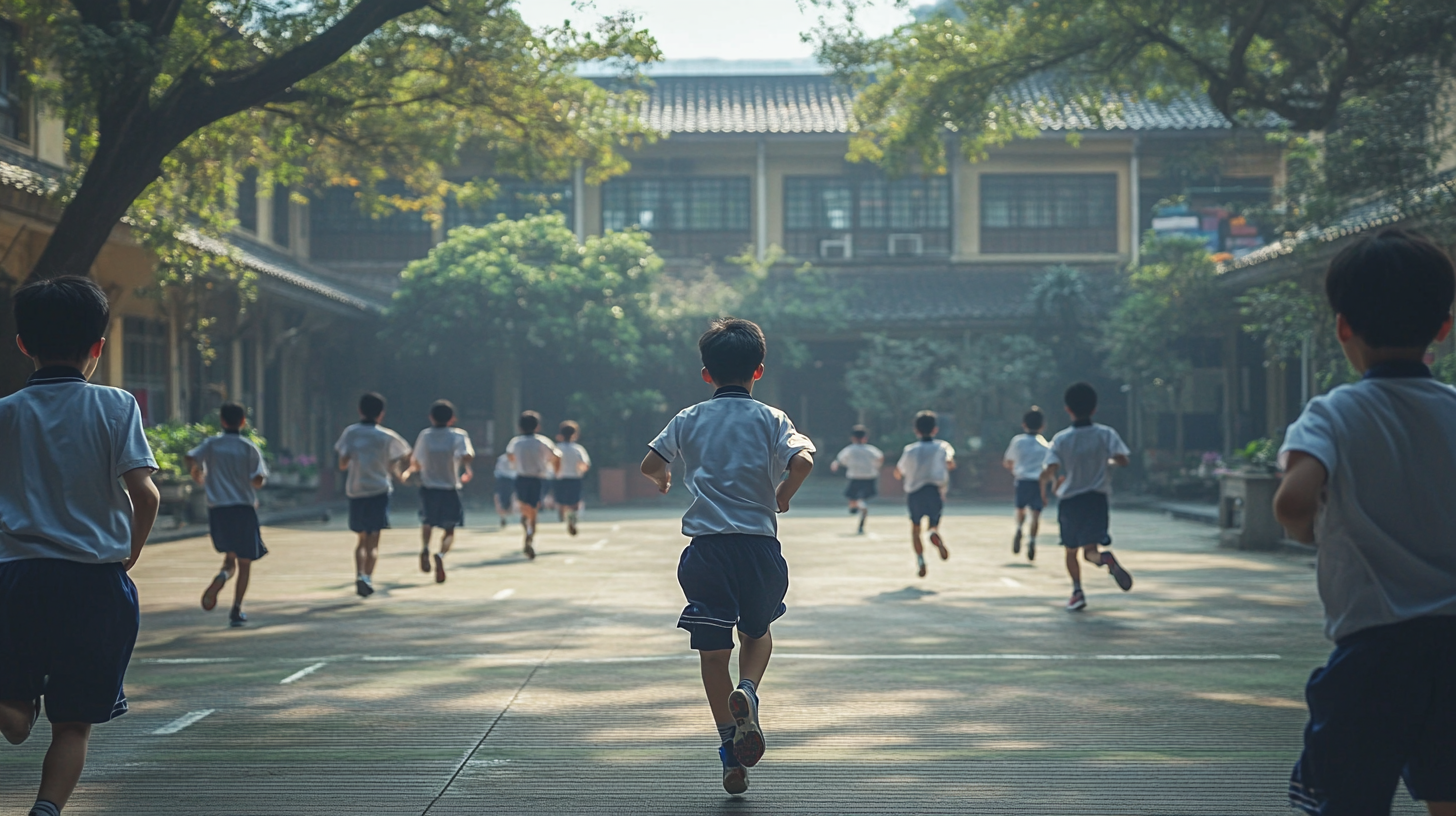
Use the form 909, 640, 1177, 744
1274, 229, 1456, 816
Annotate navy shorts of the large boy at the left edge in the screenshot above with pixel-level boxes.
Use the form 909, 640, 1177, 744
0, 558, 141, 723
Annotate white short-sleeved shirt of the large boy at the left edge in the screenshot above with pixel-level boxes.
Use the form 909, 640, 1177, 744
0, 366, 157, 564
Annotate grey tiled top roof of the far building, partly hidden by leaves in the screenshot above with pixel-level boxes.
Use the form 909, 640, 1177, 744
628, 74, 1273, 133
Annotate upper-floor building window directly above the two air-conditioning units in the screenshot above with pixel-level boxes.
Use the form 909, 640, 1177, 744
783, 175, 951, 259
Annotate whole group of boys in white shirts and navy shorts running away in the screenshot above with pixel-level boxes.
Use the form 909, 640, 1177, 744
0, 229, 1456, 816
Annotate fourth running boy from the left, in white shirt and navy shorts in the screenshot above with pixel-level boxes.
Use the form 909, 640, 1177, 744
405, 399, 475, 584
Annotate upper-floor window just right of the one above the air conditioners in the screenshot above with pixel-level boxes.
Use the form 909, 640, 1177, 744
981, 173, 1117, 254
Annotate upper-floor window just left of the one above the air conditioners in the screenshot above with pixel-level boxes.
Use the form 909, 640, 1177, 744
601, 178, 753, 255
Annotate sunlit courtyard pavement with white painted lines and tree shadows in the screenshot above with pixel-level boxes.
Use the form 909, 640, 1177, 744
0, 500, 1424, 816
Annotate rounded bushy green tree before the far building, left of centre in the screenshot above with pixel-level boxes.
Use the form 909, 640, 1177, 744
386, 214, 673, 451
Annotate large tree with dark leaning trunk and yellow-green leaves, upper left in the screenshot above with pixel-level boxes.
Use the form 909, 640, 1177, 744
8, 0, 657, 277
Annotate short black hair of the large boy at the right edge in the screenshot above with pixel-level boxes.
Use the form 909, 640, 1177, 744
1325, 227, 1456, 348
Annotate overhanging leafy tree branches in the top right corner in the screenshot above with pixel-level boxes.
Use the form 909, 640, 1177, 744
818, 0, 1456, 168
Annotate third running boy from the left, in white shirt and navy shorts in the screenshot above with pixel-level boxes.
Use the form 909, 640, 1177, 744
333, 392, 409, 597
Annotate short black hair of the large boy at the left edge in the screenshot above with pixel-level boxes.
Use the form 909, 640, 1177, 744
13, 275, 111, 361
